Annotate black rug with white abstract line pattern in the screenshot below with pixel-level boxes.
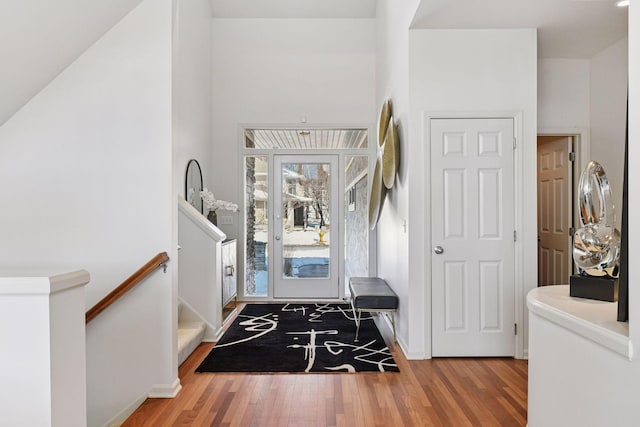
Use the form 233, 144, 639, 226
196, 304, 399, 372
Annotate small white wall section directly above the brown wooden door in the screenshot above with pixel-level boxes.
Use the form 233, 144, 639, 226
538, 58, 591, 131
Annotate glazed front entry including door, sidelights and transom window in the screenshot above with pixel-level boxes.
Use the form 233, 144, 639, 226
243, 129, 370, 298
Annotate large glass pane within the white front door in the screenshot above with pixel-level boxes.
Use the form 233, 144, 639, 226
280, 162, 332, 279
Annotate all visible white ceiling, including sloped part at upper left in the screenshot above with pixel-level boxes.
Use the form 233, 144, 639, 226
0, 0, 627, 126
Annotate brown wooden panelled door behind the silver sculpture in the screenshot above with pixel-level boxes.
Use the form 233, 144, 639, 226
538, 136, 573, 286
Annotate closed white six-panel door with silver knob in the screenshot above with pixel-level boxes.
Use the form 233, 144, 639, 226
430, 119, 516, 357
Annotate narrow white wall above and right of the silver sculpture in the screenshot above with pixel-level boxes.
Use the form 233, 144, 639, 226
590, 38, 628, 229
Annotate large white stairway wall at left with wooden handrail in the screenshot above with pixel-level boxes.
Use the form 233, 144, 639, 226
0, 0, 177, 426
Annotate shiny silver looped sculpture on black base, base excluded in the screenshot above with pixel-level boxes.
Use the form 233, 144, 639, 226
573, 161, 620, 278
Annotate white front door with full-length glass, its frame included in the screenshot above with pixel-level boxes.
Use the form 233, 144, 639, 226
273, 155, 342, 299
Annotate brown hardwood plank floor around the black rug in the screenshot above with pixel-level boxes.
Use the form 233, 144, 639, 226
123, 344, 527, 427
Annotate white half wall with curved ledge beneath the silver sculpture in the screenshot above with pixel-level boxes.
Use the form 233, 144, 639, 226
527, 285, 640, 427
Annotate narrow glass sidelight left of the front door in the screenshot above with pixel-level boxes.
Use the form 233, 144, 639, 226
244, 156, 269, 296
